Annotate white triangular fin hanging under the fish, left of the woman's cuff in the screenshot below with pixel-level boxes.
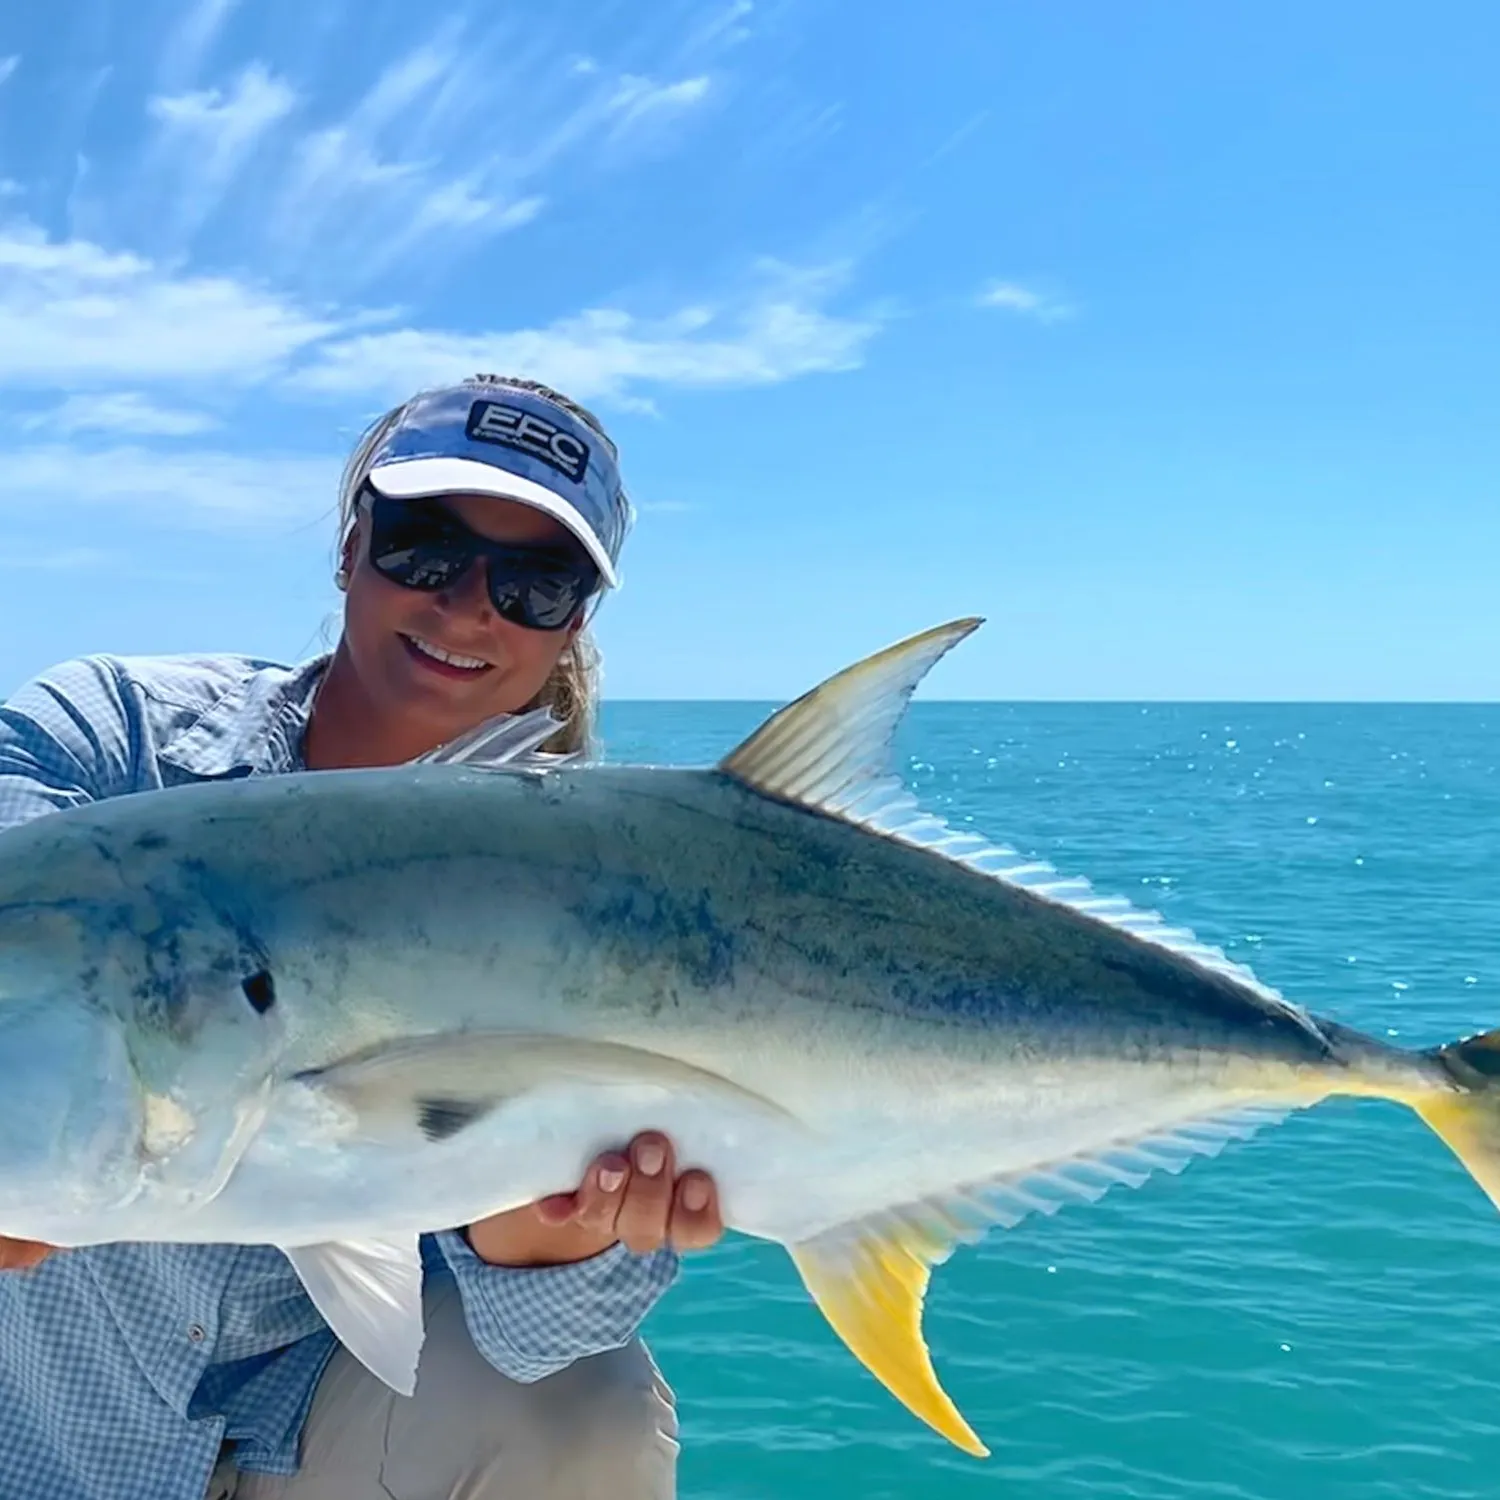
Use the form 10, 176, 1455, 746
282, 1236, 423, 1397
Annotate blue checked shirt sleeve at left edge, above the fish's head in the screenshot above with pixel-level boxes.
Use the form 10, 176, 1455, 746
0, 659, 134, 828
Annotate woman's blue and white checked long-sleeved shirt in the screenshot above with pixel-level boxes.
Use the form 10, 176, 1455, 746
0, 656, 678, 1500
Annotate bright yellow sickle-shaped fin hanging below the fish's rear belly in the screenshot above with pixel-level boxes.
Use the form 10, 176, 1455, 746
791, 1221, 990, 1458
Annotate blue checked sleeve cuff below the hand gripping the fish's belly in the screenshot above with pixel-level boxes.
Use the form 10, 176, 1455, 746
435, 1230, 681, 1383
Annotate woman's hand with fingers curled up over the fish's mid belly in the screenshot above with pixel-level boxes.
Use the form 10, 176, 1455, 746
468, 1131, 725, 1266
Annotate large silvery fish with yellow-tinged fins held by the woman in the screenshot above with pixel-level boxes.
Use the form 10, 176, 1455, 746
0, 618, 1500, 1457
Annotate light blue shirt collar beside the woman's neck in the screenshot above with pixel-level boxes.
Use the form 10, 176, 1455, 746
159, 656, 330, 777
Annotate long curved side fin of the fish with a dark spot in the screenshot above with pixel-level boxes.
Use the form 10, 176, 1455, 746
286, 1032, 788, 1143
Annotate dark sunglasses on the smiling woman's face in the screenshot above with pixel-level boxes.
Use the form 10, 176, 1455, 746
360, 488, 599, 630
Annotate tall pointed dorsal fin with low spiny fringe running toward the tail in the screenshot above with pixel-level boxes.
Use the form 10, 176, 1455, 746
719, 620, 1316, 1032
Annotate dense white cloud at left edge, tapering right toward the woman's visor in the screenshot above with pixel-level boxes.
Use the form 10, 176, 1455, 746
0, 225, 339, 389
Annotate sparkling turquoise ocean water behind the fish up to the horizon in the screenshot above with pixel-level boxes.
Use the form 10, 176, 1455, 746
605, 702, 1500, 1500
